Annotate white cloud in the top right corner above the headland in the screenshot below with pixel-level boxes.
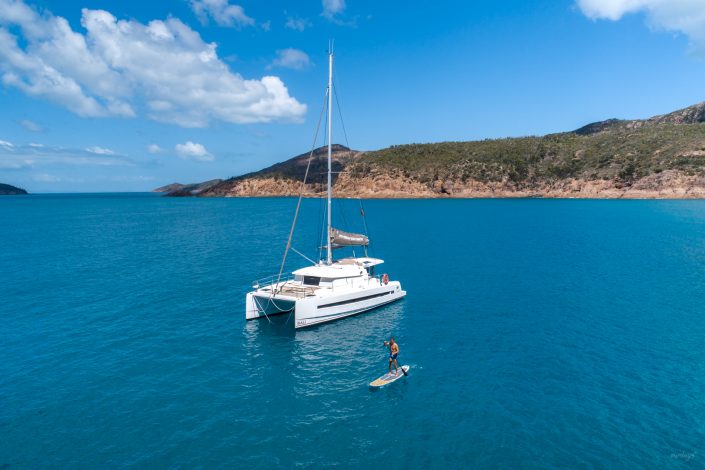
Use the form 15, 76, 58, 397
577, 0, 705, 53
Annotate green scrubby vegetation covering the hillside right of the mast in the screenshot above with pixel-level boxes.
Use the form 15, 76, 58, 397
347, 123, 705, 187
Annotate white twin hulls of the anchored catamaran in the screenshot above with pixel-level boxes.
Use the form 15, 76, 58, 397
246, 281, 406, 328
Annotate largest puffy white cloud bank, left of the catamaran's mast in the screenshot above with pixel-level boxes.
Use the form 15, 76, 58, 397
0, 0, 306, 127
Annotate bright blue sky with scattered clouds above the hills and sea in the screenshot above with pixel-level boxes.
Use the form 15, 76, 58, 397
0, 0, 705, 192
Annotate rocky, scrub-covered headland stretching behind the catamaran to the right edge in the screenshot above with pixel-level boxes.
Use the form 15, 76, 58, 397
157, 103, 705, 199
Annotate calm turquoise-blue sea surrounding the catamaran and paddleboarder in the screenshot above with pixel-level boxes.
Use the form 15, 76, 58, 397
0, 194, 705, 469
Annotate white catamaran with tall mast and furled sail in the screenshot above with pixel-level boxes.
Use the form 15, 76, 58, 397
245, 46, 406, 328
